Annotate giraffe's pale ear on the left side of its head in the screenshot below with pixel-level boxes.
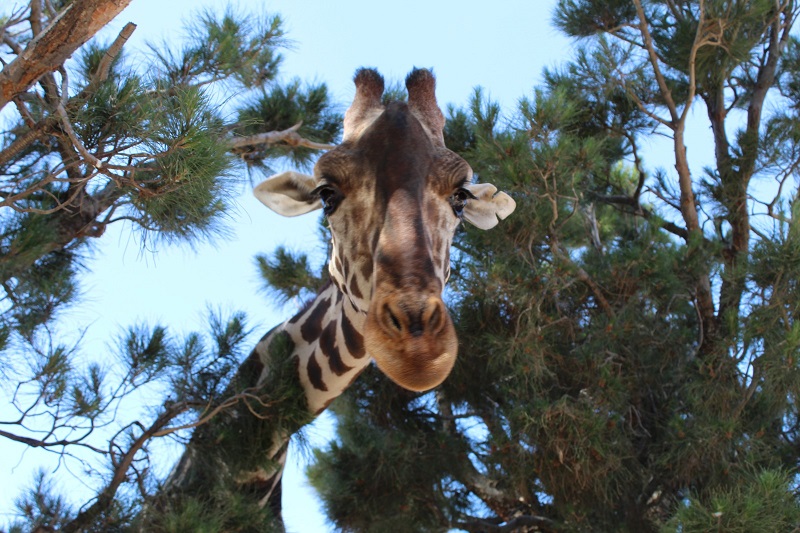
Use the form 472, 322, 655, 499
253, 170, 322, 217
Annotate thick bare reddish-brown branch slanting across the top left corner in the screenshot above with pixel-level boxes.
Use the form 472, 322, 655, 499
0, 0, 131, 109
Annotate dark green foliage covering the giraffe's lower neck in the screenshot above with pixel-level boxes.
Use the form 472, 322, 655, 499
145, 330, 313, 532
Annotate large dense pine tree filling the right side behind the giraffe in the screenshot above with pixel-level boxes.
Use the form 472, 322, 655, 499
310, 0, 800, 532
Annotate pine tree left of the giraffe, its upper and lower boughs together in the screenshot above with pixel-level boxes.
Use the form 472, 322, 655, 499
0, 0, 341, 532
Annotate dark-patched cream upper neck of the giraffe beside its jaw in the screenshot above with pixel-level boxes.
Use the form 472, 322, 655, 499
256, 283, 370, 416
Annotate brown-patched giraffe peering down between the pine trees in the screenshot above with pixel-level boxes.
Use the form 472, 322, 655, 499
164, 69, 515, 516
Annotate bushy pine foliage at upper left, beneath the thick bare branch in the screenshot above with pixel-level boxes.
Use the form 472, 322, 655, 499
0, 0, 341, 300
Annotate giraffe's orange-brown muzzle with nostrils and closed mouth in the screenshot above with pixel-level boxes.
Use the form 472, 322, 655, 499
364, 294, 458, 392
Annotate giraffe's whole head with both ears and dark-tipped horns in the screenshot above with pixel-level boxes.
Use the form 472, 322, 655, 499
255, 69, 515, 391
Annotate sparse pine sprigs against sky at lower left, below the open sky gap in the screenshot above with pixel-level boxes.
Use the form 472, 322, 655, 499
6, 306, 253, 531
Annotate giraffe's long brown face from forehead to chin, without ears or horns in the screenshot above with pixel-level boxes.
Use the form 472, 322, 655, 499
315, 103, 472, 390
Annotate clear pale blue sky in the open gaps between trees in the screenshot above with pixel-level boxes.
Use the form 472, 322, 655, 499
0, 0, 703, 533
